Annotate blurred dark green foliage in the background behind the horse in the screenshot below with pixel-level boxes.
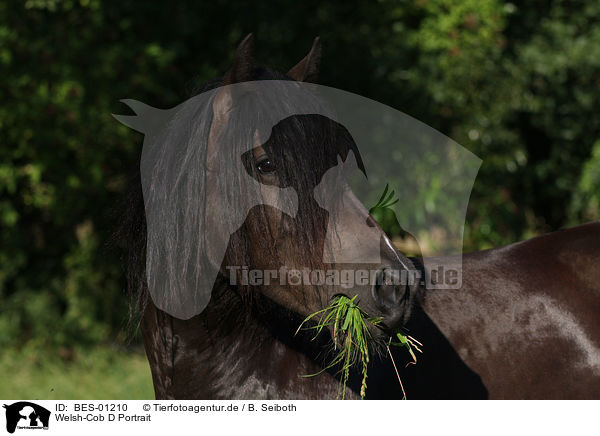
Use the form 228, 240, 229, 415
0, 0, 600, 354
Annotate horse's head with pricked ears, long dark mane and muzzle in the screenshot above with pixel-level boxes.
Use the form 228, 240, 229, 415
116, 35, 416, 338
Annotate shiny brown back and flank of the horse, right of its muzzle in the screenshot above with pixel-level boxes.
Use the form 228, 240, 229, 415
422, 222, 600, 399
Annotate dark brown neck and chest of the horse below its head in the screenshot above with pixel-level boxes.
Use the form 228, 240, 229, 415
142, 283, 344, 399
